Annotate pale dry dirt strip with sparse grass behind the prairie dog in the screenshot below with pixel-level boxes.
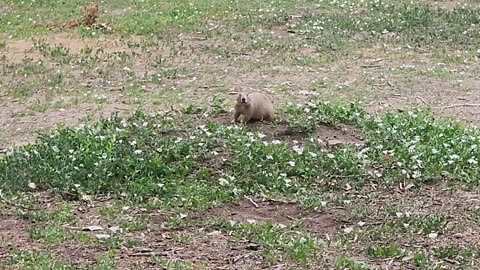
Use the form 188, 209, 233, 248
0, 33, 480, 148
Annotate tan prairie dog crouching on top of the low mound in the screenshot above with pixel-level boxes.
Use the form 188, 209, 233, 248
233, 92, 274, 123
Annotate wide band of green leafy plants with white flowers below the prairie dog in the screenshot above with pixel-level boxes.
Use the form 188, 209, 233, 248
0, 101, 480, 202
